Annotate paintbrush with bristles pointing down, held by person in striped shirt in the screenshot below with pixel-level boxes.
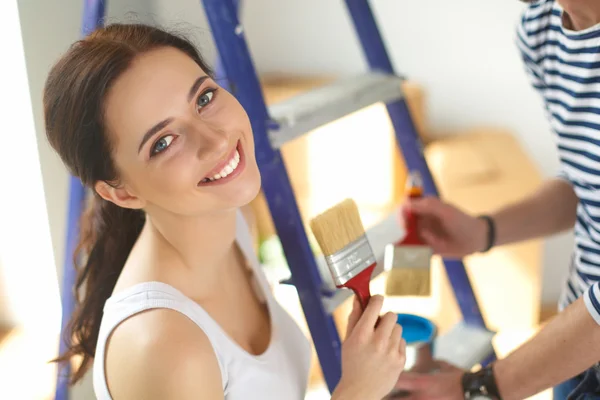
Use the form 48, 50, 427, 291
386, 171, 433, 296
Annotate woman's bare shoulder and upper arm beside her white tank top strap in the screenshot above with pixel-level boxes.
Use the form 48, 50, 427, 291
105, 309, 223, 400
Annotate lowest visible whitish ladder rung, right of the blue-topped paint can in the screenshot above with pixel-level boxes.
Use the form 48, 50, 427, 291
433, 321, 495, 370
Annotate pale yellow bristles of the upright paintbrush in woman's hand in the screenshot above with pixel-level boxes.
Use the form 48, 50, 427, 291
310, 199, 365, 256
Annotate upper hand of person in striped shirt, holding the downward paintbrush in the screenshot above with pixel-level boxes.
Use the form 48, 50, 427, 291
400, 197, 488, 258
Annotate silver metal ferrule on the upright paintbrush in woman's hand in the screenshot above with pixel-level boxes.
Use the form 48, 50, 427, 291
325, 235, 376, 287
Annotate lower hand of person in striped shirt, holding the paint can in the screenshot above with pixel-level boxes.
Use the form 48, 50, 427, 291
395, 361, 465, 400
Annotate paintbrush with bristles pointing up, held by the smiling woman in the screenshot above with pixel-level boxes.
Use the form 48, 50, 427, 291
310, 199, 377, 310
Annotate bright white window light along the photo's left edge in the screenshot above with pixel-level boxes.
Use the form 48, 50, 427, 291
0, 0, 61, 335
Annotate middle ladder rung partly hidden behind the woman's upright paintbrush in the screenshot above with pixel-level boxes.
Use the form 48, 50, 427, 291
317, 210, 404, 313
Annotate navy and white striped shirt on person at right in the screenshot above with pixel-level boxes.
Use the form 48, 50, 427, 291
517, 0, 600, 324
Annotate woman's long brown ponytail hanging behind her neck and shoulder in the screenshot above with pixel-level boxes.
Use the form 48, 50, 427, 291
55, 194, 145, 383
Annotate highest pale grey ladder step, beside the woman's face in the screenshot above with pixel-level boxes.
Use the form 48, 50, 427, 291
269, 72, 403, 149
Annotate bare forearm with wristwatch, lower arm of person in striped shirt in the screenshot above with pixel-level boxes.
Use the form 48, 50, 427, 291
494, 298, 600, 400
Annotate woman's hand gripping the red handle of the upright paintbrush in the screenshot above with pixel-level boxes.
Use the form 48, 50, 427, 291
332, 296, 406, 400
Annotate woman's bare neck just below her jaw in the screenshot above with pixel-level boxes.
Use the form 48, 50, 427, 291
139, 210, 236, 290
